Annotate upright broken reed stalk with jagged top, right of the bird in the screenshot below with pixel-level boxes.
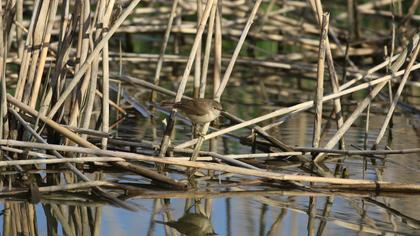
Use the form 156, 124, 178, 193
312, 13, 329, 147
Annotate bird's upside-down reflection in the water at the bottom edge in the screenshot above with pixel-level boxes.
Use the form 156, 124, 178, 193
156, 212, 217, 236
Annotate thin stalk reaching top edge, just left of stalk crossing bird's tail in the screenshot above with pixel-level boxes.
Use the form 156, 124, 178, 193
150, 0, 179, 103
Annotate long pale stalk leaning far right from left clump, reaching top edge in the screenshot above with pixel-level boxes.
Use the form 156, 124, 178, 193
48, 0, 141, 118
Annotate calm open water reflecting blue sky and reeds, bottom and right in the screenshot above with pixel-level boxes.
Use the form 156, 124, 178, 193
112, 111, 420, 235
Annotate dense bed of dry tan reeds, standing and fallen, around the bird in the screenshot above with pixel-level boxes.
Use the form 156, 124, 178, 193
0, 0, 420, 235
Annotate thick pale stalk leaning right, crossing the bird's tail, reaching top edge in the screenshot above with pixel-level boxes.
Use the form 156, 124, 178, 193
159, 0, 214, 160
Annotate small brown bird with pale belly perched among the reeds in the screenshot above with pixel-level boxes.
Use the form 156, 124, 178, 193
161, 98, 222, 125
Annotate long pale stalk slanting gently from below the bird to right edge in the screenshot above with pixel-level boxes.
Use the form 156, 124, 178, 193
175, 61, 420, 148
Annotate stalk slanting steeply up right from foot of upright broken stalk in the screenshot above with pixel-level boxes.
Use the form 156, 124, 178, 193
314, 40, 420, 163
